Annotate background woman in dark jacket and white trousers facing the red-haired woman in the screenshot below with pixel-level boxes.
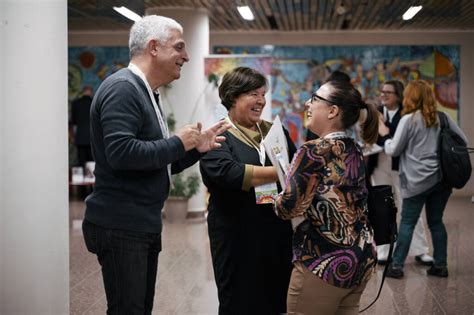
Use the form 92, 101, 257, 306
367, 80, 433, 266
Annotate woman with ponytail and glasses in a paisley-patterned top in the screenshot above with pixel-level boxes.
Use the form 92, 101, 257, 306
275, 81, 378, 315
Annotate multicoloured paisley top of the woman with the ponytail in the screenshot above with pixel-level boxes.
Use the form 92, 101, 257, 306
275, 136, 377, 288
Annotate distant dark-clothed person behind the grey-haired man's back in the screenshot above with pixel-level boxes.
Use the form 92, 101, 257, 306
71, 85, 94, 167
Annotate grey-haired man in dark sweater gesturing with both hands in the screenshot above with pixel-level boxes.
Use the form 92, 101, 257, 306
82, 15, 230, 315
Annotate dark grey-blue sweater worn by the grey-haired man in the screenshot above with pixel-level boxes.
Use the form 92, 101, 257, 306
85, 68, 201, 233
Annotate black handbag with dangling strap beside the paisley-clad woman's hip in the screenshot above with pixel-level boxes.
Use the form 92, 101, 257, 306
359, 185, 397, 313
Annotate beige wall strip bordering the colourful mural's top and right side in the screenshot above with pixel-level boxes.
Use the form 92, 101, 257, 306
69, 31, 474, 195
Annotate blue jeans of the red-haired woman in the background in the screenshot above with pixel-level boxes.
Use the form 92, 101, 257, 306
392, 183, 452, 268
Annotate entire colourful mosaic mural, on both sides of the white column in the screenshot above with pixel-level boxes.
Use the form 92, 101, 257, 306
68, 45, 460, 148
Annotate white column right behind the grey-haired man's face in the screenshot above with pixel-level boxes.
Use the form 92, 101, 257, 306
146, 7, 212, 212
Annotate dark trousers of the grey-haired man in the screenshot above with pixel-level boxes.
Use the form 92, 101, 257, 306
82, 220, 161, 315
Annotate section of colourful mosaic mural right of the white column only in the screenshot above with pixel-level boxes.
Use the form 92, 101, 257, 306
214, 45, 460, 143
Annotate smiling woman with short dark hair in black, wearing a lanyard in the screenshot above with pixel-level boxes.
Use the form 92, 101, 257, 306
200, 67, 296, 315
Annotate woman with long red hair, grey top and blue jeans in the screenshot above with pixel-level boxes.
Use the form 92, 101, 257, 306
379, 80, 467, 278
